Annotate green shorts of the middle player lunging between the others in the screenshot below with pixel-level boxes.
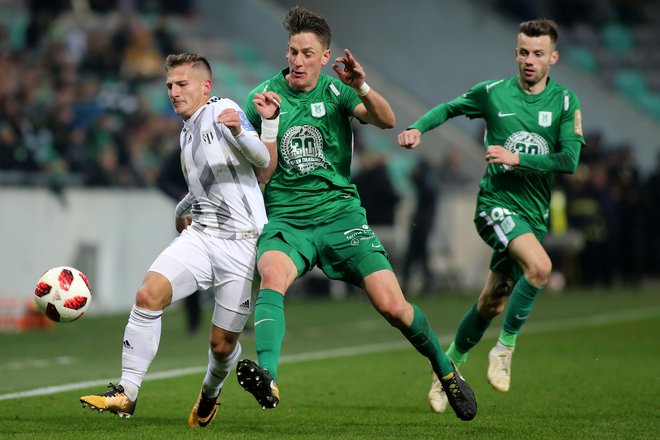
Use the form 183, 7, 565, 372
257, 211, 392, 287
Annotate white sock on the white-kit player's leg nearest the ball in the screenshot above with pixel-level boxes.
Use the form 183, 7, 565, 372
119, 305, 163, 402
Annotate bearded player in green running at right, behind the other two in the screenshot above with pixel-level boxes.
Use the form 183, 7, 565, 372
398, 20, 584, 412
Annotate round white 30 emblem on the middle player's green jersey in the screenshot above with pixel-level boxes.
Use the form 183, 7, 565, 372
280, 125, 330, 174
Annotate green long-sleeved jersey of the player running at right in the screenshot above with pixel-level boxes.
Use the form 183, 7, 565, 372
411, 76, 584, 233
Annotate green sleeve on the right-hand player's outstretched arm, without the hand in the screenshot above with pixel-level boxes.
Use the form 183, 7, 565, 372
409, 82, 487, 133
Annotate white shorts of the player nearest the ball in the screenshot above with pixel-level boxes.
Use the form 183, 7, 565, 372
149, 228, 259, 332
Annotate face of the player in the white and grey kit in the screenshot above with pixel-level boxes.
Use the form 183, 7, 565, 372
167, 65, 211, 119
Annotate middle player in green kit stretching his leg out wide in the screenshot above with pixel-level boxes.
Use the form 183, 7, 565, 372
236, 7, 477, 420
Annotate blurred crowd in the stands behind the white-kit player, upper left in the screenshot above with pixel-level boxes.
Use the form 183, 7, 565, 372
0, 0, 193, 187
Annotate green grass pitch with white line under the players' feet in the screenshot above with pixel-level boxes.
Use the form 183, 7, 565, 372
0, 291, 660, 439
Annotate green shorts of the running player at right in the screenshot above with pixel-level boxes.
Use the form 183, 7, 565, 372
474, 206, 545, 281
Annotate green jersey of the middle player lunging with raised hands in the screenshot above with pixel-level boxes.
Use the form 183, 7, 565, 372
245, 69, 363, 222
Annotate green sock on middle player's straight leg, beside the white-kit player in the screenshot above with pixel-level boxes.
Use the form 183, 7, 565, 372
254, 289, 285, 382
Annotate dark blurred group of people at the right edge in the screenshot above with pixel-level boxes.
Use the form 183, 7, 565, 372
551, 133, 660, 286
